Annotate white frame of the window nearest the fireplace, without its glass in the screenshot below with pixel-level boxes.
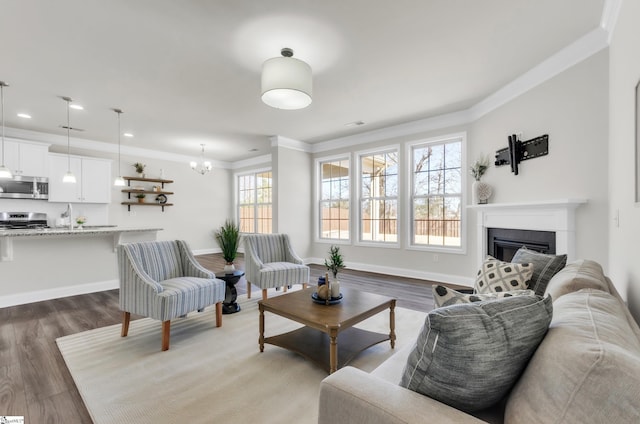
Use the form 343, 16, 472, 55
404, 132, 468, 254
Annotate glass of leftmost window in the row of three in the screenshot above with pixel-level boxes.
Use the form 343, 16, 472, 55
319, 158, 351, 240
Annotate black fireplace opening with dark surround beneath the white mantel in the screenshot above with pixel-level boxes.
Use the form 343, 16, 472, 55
487, 228, 556, 262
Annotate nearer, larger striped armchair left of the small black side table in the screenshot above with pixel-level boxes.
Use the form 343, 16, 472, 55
118, 240, 226, 350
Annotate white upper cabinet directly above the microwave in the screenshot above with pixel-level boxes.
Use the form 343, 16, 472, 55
4, 139, 49, 177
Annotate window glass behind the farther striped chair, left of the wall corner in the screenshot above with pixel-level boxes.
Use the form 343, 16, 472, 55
238, 171, 273, 234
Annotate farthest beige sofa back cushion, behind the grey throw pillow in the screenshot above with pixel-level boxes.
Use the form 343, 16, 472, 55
546, 259, 609, 300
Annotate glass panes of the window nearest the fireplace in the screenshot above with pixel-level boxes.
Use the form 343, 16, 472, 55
411, 138, 462, 247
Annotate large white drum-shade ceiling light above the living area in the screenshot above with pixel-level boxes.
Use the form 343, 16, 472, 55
262, 47, 312, 110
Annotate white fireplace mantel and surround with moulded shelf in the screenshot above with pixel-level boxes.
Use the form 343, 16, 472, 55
468, 199, 587, 266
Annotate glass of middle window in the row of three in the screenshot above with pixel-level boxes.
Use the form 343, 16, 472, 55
359, 149, 398, 244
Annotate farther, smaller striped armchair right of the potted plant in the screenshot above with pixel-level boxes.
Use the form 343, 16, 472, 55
243, 234, 309, 299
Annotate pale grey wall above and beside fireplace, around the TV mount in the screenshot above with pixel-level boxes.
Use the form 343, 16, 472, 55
468, 50, 609, 269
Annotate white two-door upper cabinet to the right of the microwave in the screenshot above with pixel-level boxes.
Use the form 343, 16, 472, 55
49, 153, 111, 203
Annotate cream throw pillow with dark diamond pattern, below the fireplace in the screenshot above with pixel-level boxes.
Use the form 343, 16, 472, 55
474, 256, 533, 294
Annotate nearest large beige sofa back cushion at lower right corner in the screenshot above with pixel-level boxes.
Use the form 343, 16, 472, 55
505, 289, 640, 424
